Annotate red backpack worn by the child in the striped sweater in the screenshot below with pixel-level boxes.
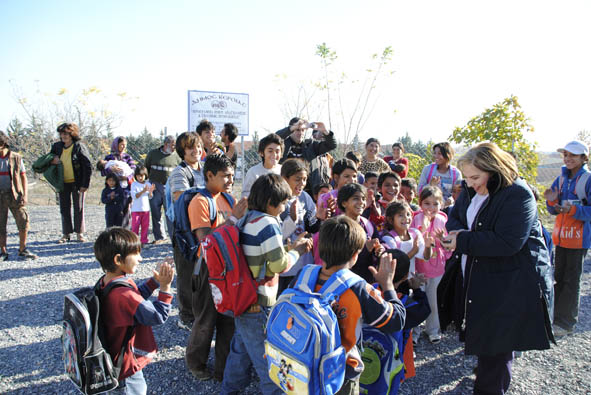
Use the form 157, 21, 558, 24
200, 211, 266, 317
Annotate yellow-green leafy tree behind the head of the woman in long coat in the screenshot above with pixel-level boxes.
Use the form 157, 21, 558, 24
450, 96, 538, 184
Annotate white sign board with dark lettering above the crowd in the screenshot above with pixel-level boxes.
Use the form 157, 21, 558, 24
188, 90, 248, 136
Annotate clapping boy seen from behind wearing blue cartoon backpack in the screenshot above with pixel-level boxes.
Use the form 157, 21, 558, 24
266, 216, 406, 394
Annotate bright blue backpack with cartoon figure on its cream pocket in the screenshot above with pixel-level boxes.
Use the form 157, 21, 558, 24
265, 265, 363, 395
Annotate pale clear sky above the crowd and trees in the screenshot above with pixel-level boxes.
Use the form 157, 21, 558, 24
0, 0, 591, 150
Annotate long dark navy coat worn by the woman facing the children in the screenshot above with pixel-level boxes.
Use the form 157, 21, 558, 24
446, 176, 554, 355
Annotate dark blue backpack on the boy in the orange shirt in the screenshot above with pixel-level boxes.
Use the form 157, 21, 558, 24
174, 187, 234, 263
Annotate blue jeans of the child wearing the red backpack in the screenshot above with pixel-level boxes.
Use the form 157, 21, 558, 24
220, 308, 283, 395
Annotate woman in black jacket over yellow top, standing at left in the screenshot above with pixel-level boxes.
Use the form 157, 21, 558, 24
51, 123, 92, 244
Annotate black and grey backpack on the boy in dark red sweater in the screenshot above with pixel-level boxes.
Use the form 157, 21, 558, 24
62, 279, 134, 394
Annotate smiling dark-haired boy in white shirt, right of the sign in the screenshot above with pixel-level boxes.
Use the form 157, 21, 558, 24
241, 133, 284, 197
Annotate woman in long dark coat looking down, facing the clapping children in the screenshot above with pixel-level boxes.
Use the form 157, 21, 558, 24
444, 143, 554, 394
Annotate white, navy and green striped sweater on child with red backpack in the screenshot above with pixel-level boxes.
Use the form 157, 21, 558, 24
240, 211, 300, 306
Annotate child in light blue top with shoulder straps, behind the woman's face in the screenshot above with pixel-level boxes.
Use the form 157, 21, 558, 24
419, 142, 462, 207
